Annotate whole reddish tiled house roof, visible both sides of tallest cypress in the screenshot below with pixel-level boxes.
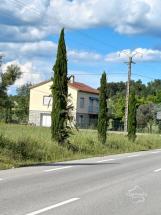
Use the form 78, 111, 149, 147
30, 80, 99, 94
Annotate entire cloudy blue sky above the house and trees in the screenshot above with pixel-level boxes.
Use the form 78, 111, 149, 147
0, 0, 161, 93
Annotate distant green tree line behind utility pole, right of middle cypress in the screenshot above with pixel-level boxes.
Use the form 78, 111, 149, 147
103, 79, 161, 132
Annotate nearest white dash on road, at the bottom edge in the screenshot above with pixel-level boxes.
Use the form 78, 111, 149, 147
26, 198, 80, 215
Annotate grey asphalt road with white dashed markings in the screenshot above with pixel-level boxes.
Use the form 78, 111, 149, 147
0, 150, 161, 215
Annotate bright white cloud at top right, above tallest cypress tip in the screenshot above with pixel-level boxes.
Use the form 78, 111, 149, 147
49, 0, 161, 34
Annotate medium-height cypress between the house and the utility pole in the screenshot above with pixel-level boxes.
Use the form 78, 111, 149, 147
97, 72, 108, 144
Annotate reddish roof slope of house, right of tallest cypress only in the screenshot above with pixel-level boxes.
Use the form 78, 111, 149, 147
69, 82, 99, 94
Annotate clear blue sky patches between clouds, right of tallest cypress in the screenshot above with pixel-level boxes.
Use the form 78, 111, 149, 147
63, 27, 161, 83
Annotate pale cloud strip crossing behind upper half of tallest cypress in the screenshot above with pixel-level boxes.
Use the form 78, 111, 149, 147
0, 41, 103, 63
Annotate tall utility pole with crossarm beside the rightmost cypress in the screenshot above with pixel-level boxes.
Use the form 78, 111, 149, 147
123, 52, 142, 132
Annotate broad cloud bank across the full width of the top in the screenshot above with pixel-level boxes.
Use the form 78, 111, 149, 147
0, 0, 161, 42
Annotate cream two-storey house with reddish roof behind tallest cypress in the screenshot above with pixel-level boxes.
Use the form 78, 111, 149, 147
29, 76, 99, 128
